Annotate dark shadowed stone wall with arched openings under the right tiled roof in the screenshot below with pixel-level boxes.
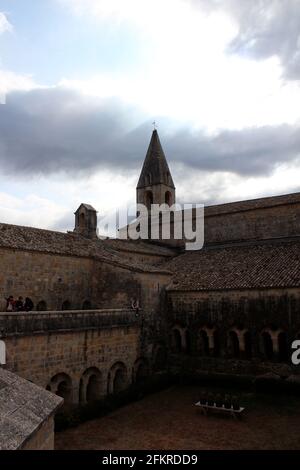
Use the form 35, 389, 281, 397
168, 288, 300, 376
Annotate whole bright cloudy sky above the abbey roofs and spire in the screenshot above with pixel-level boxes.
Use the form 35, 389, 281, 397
0, 0, 300, 230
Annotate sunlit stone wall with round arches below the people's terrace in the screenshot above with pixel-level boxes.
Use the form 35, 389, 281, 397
0, 310, 162, 404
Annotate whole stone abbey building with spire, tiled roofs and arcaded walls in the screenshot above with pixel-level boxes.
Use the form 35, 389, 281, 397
0, 130, 300, 447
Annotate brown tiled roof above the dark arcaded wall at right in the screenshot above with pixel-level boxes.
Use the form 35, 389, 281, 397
164, 237, 300, 291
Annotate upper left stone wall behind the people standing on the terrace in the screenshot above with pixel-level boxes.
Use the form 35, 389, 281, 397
0, 249, 170, 311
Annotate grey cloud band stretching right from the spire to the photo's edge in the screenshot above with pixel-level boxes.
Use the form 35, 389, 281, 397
165, 125, 300, 175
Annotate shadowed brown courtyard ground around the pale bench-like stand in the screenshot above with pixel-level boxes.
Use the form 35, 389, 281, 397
56, 386, 300, 450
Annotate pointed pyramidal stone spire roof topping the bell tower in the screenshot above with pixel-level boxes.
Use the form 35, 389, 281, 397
137, 129, 175, 188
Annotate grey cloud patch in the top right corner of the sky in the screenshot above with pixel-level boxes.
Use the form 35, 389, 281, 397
187, 0, 300, 79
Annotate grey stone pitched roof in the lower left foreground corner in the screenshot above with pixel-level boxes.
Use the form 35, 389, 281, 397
0, 367, 63, 450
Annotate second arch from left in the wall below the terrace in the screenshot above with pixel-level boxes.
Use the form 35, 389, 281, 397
79, 367, 103, 403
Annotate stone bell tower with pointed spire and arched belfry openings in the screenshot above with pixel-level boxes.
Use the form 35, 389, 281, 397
137, 129, 176, 209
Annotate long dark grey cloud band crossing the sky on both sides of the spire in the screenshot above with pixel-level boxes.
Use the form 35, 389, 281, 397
0, 88, 300, 175
